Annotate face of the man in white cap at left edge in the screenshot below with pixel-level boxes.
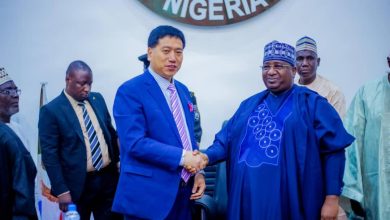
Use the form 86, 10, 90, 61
0, 81, 19, 119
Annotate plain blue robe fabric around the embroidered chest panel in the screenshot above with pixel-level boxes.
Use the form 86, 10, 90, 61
205, 85, 354, 220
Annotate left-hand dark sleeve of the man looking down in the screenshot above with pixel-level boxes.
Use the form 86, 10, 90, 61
38, 106, 69, 196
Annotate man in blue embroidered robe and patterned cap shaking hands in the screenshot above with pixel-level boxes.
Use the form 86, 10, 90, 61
205, 41, 353, 219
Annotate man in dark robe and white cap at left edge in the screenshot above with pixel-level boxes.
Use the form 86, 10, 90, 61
0, 68, 37, 219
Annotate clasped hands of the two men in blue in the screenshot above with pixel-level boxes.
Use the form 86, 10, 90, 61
183, 150, 209, 174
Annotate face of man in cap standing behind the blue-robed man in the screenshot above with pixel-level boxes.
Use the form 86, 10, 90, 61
296, 50, 320, 84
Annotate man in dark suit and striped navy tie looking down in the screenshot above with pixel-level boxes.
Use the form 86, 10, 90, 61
38, 61, 119, 220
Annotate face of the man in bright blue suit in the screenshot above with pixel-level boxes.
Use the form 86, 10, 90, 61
148, 36, 183, 81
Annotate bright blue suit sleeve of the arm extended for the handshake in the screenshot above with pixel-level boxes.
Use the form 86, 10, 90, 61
114, 85, 183, 170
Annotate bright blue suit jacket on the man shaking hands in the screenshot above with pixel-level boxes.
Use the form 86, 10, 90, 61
113, 71, 197, 219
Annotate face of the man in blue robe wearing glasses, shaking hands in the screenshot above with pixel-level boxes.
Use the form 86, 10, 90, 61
262, 60, 296, 93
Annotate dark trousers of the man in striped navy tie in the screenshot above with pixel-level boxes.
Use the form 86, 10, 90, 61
76, 166, 123, 220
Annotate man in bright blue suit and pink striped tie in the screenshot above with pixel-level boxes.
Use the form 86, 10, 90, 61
113, 26, 205, 219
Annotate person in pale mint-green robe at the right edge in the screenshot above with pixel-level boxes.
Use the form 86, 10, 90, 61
343, 55, 390, 220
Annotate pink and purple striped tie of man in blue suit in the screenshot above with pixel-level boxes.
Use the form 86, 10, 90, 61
168, 84, 192, 182
